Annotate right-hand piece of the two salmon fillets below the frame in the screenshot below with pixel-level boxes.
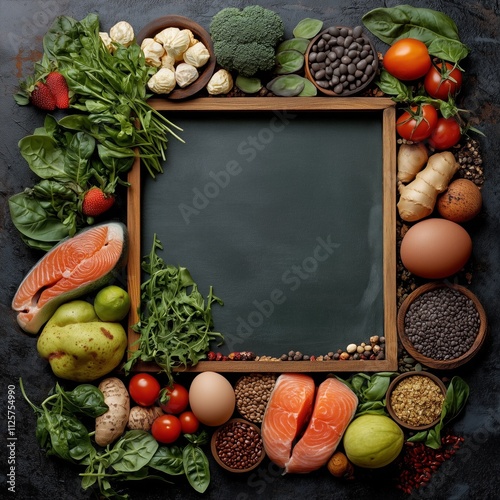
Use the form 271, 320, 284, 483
285, 378, 358, 473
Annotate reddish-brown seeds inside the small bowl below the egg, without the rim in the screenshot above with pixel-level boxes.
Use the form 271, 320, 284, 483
215, 421, 263, 469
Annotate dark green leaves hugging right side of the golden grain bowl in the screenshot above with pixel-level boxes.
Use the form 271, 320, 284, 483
408, 376, 469, 450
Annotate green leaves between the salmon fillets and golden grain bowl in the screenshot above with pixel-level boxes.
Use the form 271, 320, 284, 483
337, 372, 397, 417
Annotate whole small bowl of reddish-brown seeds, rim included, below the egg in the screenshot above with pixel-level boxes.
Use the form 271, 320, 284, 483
211, 418, 265, 473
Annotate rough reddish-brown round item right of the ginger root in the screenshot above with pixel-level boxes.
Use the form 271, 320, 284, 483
436, 179, 483, 223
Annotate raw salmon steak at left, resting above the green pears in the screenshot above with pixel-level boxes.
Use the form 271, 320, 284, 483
12, 222, 128, 333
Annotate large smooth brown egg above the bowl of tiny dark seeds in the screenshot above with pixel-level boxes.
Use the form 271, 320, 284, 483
400, 218, 472, 279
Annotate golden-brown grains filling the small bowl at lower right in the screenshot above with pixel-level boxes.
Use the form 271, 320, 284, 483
391, 375, 444, 427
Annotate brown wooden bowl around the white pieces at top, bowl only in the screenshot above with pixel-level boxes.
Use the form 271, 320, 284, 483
136, 16, 216, 99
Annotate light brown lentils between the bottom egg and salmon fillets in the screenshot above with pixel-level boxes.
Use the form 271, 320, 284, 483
234, 373, 277, 423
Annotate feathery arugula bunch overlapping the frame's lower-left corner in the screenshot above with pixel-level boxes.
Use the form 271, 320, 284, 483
124, 234, 223, 385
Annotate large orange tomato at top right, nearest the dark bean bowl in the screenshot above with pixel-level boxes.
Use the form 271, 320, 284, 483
383, 38, 432, 81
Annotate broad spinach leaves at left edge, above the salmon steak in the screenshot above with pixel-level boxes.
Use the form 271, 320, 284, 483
9, 115, 135, 250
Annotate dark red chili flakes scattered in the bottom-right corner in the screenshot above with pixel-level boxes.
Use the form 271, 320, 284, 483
396, 434, 464, 494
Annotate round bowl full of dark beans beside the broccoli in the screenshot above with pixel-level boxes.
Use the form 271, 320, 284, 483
305, 26, 378, 96
